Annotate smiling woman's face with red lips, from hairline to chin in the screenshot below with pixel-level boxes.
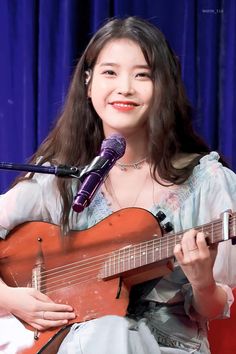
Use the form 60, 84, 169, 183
88, 38, 153, 136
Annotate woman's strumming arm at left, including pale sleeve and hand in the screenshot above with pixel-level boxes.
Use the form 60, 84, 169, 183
0, 176, 75, 330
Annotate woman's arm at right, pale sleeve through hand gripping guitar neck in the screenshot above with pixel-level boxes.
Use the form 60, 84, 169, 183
175, 152, 236, 318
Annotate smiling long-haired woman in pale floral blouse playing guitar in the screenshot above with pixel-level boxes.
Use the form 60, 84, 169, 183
0, 17, 236, 354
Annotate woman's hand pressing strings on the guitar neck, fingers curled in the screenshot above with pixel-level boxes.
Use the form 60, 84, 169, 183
174, 230, 216, 290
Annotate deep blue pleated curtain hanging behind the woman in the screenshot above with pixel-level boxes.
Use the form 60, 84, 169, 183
0, 0, 236, 192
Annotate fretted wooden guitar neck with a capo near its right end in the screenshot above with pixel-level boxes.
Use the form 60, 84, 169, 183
102, 212, 236, 278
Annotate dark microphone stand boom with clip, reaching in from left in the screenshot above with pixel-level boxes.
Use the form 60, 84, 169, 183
0, 156, 108, 182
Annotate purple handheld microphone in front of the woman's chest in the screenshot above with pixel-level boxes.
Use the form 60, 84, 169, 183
72, 134, 126, 213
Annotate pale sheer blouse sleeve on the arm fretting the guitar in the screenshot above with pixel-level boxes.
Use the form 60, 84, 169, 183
182, 153, 236, 317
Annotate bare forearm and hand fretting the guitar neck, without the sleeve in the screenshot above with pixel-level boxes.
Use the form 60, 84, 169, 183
174, 230, 227, 319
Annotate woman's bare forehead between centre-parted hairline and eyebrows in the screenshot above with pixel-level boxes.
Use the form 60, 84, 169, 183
96, 38, 147, 66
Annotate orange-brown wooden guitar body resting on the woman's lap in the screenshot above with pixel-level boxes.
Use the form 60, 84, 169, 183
0, 208, 167, 354
